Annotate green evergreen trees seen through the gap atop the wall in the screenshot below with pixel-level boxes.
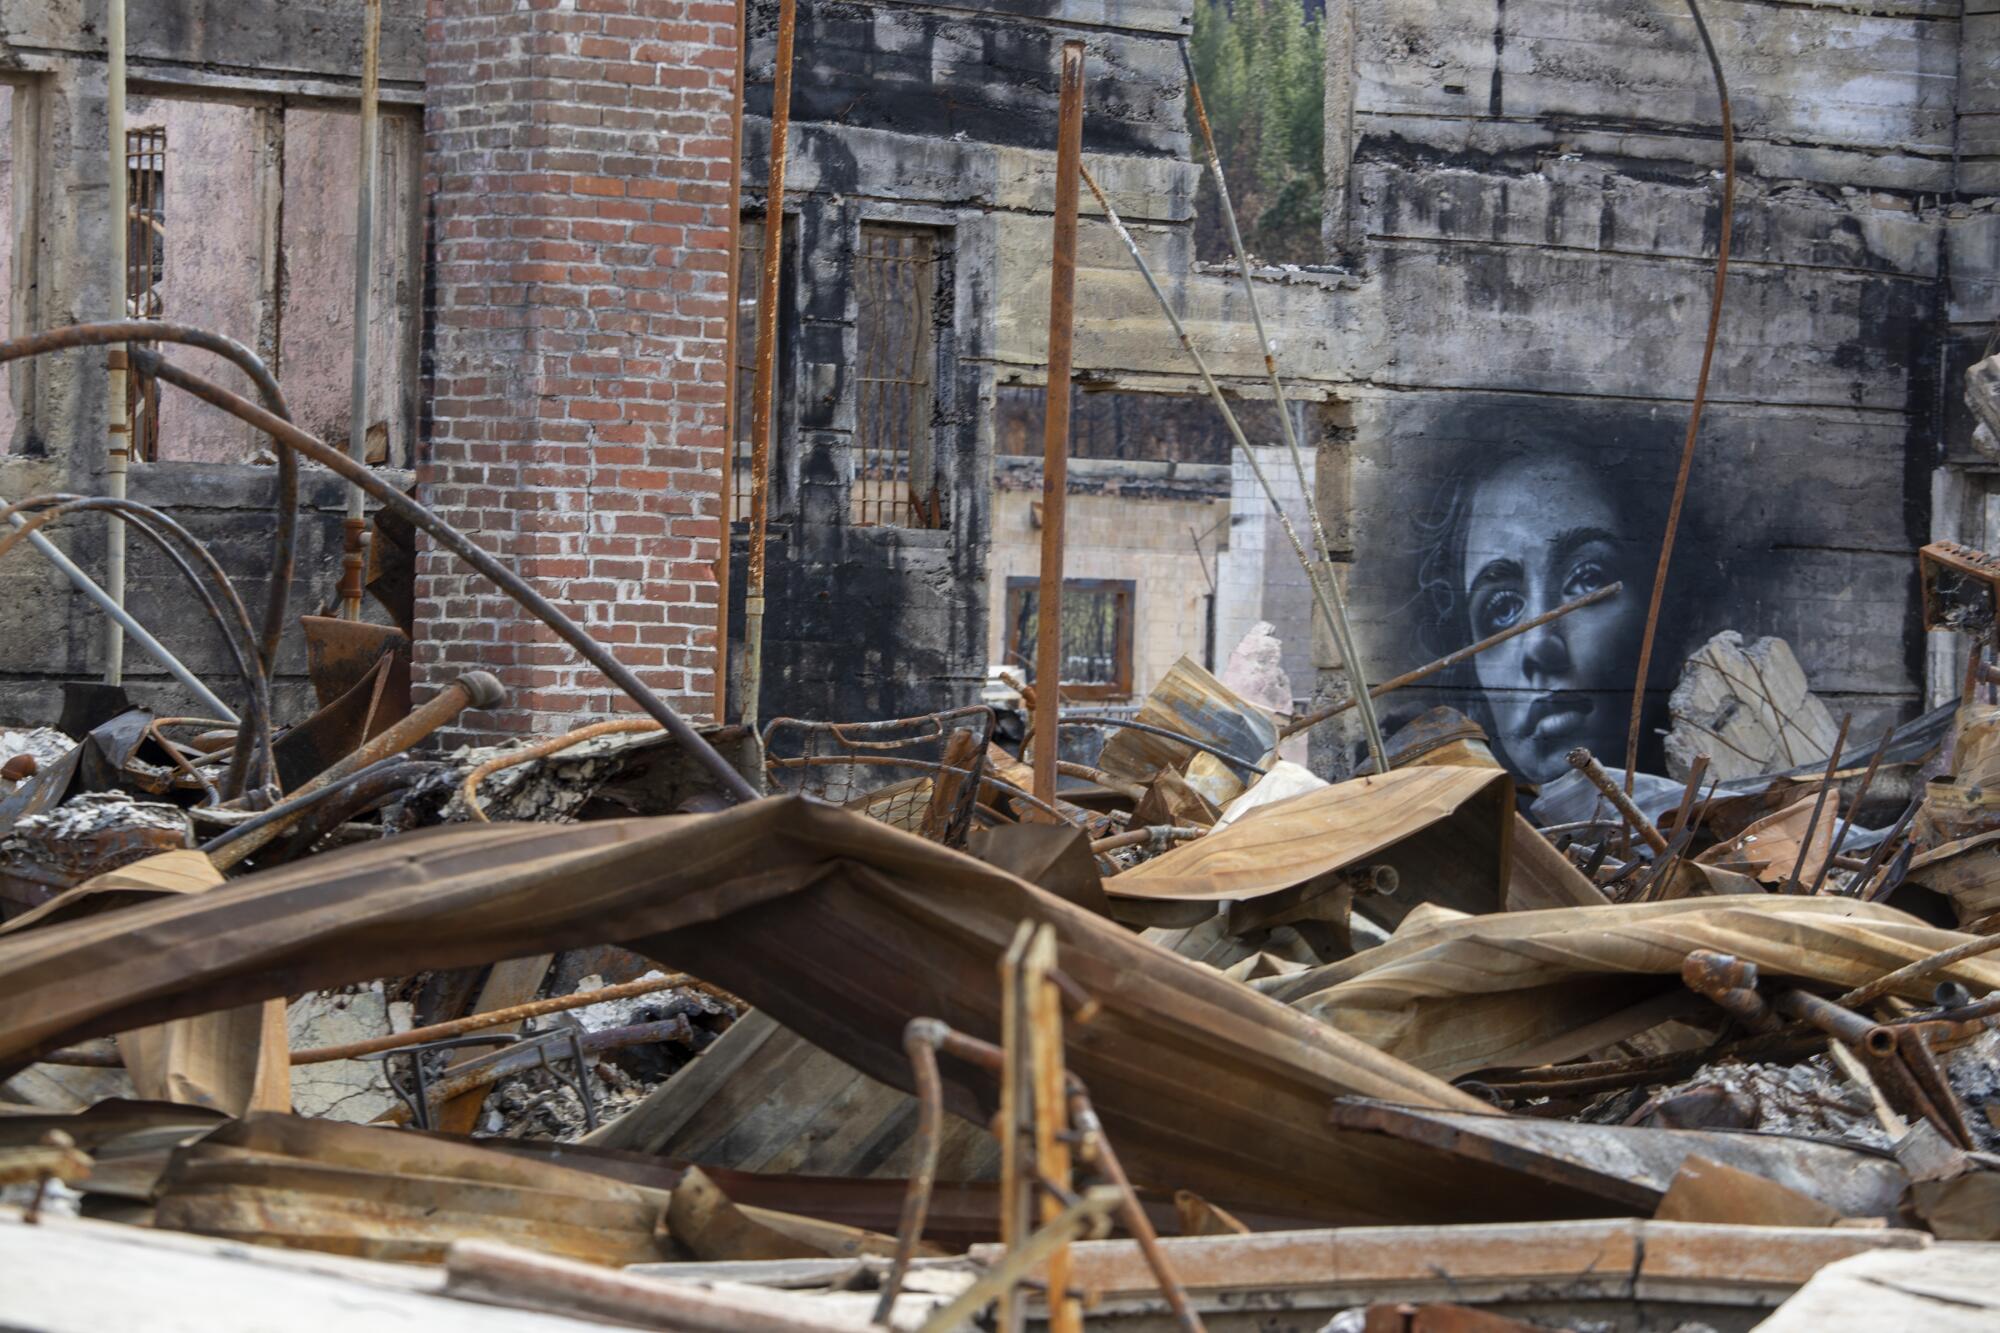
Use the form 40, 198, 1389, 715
1188, 0, 1326, 264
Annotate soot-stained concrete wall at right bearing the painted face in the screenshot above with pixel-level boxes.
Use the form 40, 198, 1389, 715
1320, 0, 1968, 779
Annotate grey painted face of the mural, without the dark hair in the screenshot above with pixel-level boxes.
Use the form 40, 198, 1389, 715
1460, 458, 1644, 783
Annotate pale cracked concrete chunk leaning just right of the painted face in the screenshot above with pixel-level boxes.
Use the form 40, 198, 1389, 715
1666, 630, 1838, 783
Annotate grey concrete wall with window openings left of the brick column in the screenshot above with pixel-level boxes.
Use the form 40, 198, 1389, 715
0, 0, 424, 721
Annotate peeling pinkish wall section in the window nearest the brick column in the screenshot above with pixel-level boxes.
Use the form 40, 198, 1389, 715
278, 108, 422, 464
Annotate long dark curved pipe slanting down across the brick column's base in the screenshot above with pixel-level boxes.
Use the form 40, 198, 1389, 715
119, 344, 758, 801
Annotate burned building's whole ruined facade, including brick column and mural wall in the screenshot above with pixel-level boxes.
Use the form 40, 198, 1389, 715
0, 0, 1996, 775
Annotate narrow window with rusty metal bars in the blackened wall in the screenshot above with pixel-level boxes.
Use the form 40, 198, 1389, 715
852, 224, 946, 528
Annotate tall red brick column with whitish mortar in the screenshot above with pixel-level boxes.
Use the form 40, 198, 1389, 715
416, 0, 738, 739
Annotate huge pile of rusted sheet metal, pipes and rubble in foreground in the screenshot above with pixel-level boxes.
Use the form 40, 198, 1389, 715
0, 324, 2000, 1333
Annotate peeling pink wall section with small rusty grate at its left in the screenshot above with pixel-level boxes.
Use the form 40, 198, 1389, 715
126, 98, 262, 462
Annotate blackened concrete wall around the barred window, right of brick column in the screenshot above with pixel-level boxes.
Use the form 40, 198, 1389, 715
732, 0, 1188, 719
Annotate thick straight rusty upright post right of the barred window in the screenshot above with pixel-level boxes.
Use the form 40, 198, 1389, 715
1034, 42, 1084, 801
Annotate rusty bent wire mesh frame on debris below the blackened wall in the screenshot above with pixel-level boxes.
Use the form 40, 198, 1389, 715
764, 707, 994, 847
